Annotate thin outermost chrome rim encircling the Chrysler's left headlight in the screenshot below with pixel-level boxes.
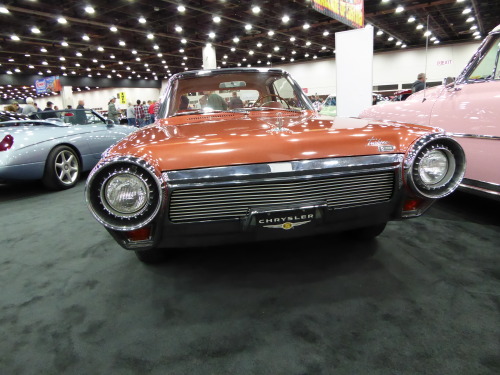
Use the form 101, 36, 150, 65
84, 155, 166, 231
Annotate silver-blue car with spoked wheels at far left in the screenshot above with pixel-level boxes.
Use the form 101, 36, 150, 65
0, 109, 136, 190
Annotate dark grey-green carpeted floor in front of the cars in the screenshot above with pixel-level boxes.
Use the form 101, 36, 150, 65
0, 181, 500, 375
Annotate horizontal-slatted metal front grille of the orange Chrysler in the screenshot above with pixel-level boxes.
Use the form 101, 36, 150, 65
169, 170, 395, 223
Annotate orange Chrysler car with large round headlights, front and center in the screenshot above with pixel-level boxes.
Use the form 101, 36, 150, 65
85, 68, 465, 263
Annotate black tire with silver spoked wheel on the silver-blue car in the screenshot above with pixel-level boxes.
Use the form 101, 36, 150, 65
42, 146, 81, 190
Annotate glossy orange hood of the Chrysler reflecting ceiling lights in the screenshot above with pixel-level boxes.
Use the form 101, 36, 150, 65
105, 113, 436, 171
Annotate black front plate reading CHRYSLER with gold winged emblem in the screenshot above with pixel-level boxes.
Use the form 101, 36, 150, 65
245, 204, 326, 231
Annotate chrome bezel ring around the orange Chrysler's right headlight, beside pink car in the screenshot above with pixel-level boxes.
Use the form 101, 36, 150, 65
405, 134, 466, 199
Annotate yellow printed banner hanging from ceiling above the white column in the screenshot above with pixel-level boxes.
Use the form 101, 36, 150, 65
312, 0, 365, 29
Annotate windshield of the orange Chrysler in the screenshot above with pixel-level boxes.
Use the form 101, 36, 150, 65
159, 69, 313, 118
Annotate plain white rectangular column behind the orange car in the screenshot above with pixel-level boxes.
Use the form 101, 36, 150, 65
335, 26, 373, 117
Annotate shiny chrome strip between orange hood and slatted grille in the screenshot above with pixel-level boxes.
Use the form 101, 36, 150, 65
162, 154, 404, 183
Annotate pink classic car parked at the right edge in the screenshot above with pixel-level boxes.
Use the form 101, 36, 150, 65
359, 25, 500, 200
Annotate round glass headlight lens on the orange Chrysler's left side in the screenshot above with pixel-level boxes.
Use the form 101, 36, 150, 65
103, 173, 149, 215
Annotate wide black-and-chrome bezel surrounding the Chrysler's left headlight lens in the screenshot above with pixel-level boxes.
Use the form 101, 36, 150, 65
85, 156, 165, 231
